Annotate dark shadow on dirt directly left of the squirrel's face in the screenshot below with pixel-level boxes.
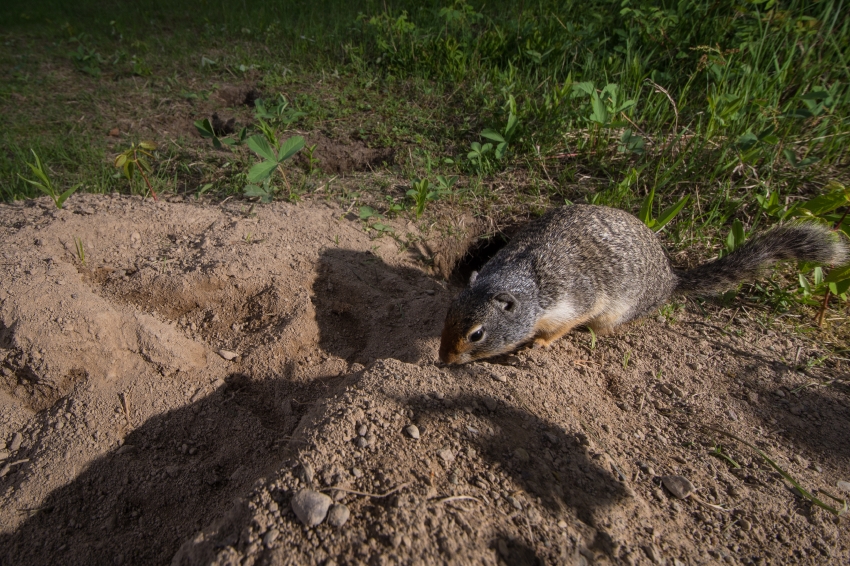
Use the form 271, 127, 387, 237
313, 248, 449, 364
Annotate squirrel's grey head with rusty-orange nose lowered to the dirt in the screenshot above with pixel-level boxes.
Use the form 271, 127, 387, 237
440, 286, 533, 364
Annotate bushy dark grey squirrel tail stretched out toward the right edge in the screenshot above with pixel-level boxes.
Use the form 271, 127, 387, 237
674, 222, 850, 294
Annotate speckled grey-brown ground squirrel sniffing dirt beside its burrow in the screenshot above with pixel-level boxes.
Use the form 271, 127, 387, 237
440, 205, 850, 364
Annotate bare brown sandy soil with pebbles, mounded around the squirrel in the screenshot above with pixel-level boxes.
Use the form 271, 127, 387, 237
0, 195, 850, 565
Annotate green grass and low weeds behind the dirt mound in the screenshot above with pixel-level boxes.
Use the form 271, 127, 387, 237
0, 0, 850, 246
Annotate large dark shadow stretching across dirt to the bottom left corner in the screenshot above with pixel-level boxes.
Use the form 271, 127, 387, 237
0, 374, 344, 566
